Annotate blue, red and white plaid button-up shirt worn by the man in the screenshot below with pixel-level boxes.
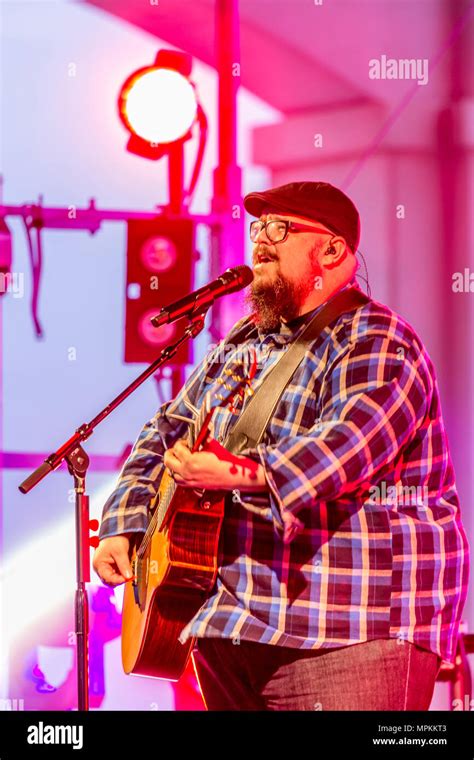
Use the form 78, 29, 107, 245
99, 284, 469, 662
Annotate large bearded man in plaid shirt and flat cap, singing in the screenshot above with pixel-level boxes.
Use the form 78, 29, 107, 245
94, 182, 468, 710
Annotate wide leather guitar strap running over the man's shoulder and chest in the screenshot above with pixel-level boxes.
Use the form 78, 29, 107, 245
223, 288, 371, 454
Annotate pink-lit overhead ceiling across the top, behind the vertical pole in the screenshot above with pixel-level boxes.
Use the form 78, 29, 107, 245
78, 0, 466, 113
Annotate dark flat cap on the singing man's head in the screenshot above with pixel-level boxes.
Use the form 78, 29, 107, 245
244, 182, 360, 253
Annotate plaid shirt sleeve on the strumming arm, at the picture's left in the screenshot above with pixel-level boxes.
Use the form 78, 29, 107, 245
99, 317, 250, 540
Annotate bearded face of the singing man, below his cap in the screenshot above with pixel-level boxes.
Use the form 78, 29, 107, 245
246, 213, 334, 329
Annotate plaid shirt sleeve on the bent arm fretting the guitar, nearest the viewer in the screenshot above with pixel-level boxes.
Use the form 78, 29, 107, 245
242, 335, 433, 536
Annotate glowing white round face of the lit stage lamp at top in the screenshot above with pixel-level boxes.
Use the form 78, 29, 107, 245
119, 67, 198, 145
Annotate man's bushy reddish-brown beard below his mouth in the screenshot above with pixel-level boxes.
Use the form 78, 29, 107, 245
245, 250, 320, 330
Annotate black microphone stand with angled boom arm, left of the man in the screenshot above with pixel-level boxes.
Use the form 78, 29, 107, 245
19, 306, 210, 711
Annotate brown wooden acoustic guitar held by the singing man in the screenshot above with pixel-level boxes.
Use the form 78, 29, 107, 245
122, 360, 256, 681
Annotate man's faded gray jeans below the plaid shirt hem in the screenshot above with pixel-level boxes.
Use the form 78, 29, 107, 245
193, 638, 441, 710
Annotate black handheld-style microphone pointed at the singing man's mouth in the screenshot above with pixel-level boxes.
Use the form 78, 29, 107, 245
150, 266, 253, 327
